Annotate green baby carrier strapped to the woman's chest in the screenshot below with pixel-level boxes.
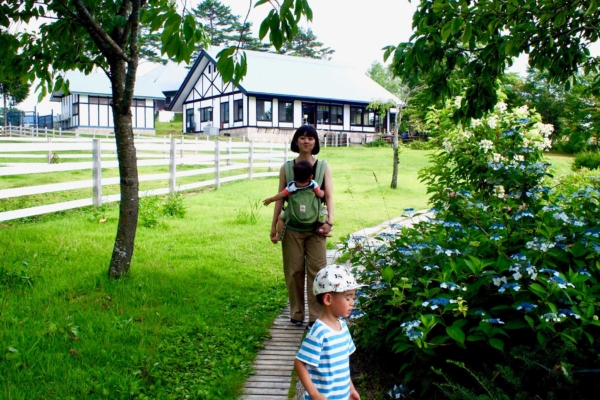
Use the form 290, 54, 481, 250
284, 160, 327, 232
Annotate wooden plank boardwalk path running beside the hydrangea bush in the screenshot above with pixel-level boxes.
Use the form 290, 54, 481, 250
241, 213, 431, 400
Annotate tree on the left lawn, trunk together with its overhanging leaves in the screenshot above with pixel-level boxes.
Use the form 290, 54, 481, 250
0, 0, 312, 278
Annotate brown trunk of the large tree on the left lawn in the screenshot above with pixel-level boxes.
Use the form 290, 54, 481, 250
108, 60, 139, 279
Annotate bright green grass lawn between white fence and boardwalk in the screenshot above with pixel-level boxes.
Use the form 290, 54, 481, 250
0, 147, 569, 400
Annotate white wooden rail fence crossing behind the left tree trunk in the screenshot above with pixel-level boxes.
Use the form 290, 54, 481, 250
0, 136, 288, 221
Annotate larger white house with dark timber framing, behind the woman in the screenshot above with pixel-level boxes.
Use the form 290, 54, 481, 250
169, 47, 401, 143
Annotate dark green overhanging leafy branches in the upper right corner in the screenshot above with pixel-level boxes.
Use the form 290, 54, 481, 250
384, 0, 600, 118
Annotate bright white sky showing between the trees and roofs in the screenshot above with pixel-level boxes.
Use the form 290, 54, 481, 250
19, 0, 600, 115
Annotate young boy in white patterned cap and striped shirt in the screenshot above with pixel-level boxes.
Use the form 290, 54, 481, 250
294, 265, 360, 400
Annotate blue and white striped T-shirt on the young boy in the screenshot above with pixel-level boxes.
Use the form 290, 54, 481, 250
296, 318, 356, 400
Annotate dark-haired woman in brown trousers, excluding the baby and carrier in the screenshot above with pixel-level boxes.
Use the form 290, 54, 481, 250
270, 125, 334, 326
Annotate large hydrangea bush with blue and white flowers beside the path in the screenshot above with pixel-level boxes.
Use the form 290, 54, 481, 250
352, 99, 600, 398
